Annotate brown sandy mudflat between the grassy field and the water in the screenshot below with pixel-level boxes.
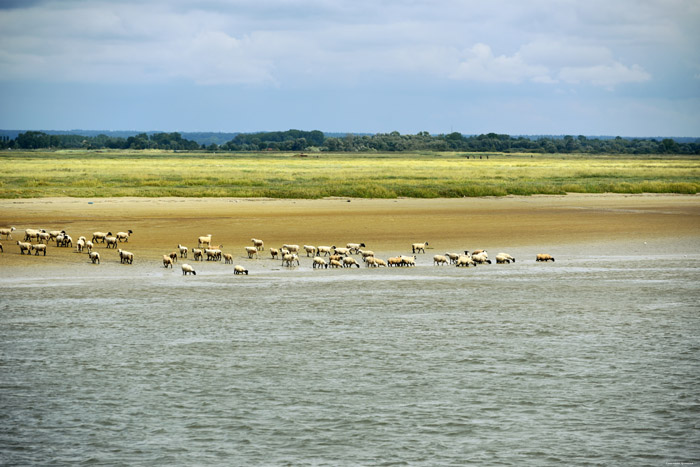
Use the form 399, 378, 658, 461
0, 194, 700, 266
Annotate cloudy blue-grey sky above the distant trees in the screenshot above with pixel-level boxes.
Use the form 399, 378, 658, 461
0, 0, 700, 136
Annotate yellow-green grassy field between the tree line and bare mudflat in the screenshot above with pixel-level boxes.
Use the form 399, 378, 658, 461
0, 151, 700, 199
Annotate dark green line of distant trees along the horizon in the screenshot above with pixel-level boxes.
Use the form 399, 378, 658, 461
0, 130, 700, 155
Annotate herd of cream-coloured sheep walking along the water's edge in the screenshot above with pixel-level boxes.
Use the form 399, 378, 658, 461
0, 227, 554, 275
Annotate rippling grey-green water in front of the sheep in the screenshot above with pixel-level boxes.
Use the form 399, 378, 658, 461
0, 255, 700, 466
